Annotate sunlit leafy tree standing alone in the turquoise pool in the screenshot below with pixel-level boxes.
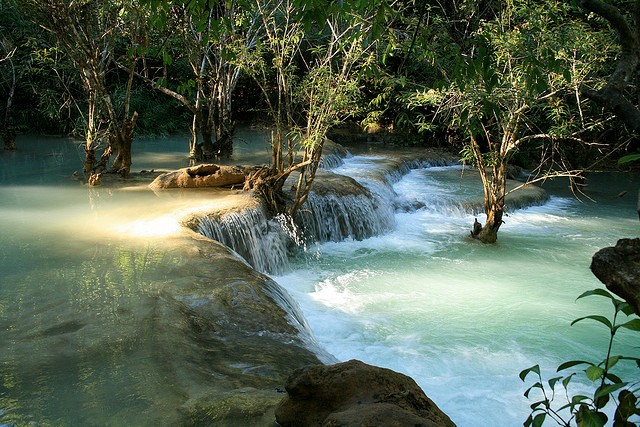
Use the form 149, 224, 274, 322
416, 1, 602, 243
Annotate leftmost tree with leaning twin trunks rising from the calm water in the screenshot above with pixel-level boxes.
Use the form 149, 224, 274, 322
19, 0, 142, 185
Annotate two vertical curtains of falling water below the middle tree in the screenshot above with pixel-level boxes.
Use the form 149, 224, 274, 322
192, 187, 395, 274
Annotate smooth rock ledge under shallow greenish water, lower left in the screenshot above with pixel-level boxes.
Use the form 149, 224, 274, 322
0, 229, 324, 427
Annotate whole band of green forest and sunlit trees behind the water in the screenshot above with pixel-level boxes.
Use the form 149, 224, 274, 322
0, 0, 640, 241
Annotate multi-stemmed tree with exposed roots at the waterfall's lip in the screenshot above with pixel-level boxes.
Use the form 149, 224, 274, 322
244, 0, 373, 217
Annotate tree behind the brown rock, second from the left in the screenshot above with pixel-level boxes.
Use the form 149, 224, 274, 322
137, 0, 261, 159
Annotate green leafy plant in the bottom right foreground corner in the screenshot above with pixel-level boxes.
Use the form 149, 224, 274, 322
520, 289, 640, 427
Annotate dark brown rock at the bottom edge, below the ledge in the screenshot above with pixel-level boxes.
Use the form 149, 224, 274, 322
276, 360, 455, 427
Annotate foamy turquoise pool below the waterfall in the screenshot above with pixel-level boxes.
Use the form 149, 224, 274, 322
276, 156, 640, 427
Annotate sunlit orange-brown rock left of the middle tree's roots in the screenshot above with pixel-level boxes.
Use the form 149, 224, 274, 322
149, 164, 246, 190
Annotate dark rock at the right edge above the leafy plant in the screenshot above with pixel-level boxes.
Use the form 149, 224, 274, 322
591, 239, 640, 316
